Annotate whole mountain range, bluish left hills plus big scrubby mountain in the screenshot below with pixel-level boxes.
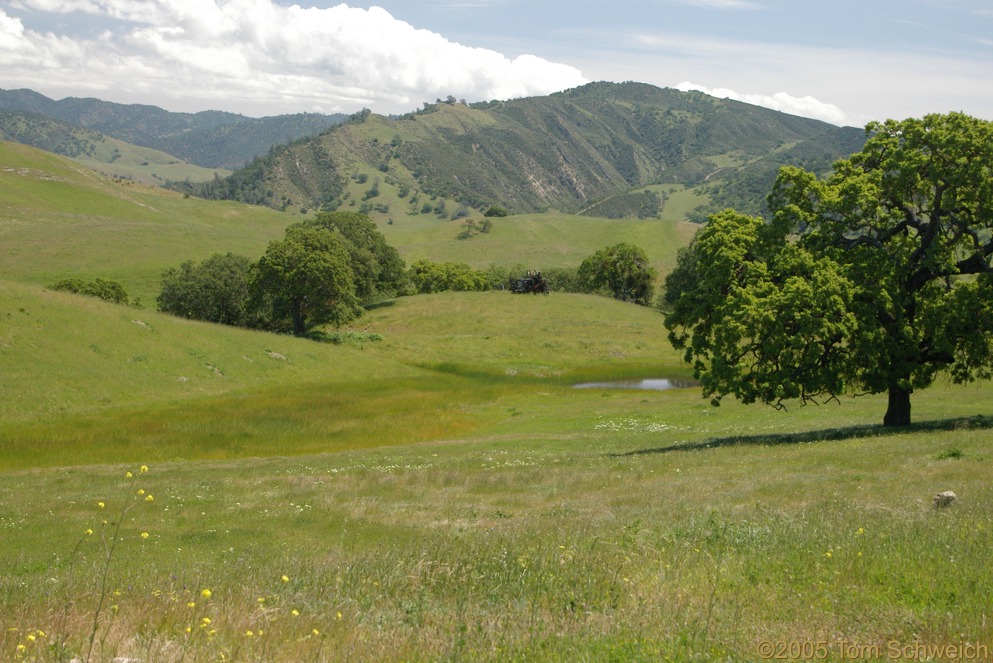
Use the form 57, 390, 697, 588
0, 82, 865, 221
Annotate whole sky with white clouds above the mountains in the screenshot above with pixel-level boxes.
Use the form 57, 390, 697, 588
0, 0, 993, 126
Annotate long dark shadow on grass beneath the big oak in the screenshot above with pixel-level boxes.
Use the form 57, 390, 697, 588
611, 415, 993, 457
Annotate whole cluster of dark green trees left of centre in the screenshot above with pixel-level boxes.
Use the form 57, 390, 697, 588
157, 212, 406, 335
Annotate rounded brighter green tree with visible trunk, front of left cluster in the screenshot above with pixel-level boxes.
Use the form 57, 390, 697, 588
252, 224, 362, 336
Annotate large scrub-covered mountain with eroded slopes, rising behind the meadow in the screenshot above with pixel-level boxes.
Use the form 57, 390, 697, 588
182, 83, 864, 218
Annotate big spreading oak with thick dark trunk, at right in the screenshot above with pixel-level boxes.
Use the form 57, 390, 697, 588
666, 113, 993, 426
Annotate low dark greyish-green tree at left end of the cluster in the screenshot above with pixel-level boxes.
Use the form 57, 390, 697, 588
156, 253, 252, 327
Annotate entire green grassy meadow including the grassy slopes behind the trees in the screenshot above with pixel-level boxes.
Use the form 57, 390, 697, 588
0, 146, 993, 662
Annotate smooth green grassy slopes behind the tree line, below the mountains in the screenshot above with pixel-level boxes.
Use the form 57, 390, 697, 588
0, 141, 695, 306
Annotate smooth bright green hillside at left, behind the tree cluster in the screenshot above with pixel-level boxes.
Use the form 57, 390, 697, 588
0, 142, 292, 306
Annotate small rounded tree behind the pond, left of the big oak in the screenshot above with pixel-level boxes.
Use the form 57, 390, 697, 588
578, 243, 656, 306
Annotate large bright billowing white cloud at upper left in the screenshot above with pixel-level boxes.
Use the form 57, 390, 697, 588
0, 0, 586, 113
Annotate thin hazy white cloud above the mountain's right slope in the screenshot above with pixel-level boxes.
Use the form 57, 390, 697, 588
572, 30, 993, 127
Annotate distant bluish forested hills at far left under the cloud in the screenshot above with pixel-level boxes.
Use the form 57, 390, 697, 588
0, 90, 345, 170
